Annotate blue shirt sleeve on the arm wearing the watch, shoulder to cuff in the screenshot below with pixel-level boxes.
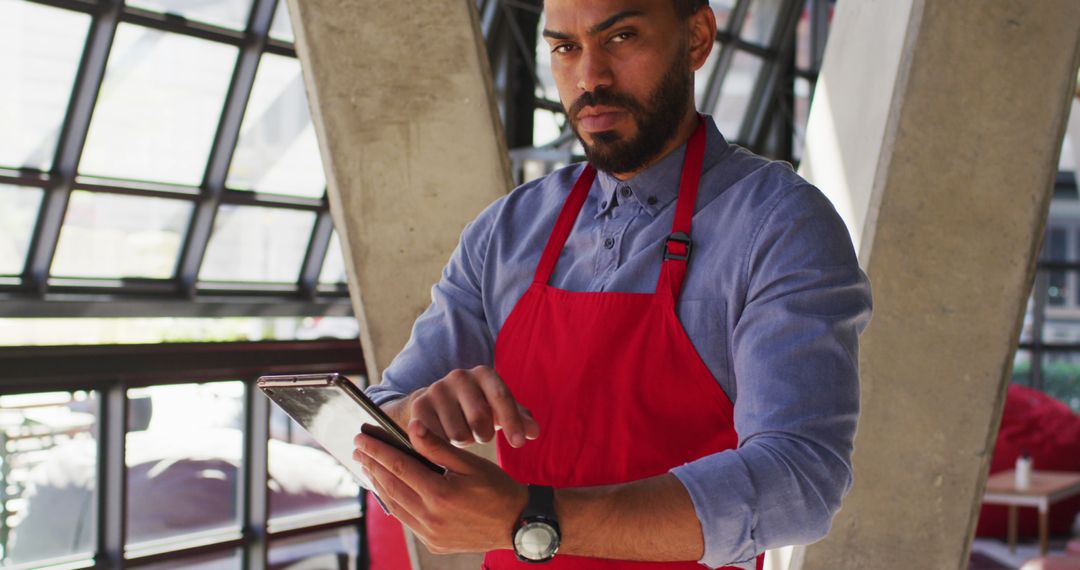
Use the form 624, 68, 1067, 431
672, 187, 870, 568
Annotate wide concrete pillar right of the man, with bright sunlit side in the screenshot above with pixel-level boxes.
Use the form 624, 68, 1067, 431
795, 0, 1080, 569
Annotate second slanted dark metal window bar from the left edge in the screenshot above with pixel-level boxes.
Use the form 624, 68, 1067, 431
176, 0, 276, 298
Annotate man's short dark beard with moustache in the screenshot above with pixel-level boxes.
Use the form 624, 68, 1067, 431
567, 57, 693, 174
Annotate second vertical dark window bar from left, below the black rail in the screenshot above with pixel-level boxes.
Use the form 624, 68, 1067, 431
239, 380, 270, 570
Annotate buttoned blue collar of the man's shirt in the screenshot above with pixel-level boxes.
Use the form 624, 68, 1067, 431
593, 116, 730, 218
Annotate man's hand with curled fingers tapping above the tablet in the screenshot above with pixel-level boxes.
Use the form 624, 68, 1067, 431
383, 366, 540, 447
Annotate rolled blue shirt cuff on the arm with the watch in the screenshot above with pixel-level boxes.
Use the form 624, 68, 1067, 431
671, 451, 757, 568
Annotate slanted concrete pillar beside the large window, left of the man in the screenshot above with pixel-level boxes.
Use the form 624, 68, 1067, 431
288, 0, 512, 570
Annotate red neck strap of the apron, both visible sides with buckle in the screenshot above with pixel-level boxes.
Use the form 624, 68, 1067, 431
532, 116, 705, 301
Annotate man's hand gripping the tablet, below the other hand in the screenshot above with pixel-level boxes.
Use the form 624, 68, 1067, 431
352, 420, 528, 554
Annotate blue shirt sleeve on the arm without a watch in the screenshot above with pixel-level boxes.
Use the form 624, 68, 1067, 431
366, 200, 502, 405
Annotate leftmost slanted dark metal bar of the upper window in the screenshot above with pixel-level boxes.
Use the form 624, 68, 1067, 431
23, 0, 123, 295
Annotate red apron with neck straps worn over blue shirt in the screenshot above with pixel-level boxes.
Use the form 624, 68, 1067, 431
484, 123, 764, 570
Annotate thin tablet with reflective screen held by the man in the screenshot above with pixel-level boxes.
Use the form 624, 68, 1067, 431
256, 374, 446, 491
